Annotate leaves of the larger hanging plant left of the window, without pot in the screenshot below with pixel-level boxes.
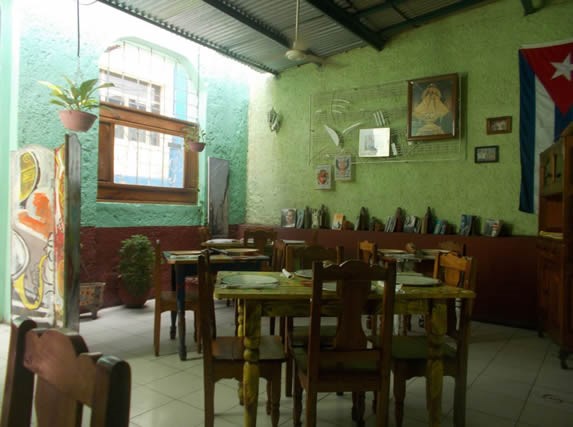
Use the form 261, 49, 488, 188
39, 76, 114, 112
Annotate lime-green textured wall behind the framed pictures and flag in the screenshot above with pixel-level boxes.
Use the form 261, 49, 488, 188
247, 0, 573, 235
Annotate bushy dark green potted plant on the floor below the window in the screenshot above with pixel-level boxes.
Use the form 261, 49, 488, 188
119, 234, 155, 308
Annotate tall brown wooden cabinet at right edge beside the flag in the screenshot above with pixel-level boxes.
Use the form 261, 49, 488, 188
537, 136, 573, 368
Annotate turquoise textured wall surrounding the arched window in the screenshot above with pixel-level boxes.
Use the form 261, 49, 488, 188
18, 0, 254, 231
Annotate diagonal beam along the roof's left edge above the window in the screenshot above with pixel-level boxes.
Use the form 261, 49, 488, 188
97, 0, 279, 75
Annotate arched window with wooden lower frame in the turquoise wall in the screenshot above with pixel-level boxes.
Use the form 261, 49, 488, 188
98, 41, 198, 203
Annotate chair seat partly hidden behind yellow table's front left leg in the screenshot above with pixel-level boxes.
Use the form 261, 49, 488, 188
212, 335, 286, 361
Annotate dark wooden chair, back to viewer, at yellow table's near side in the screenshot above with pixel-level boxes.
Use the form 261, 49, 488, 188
293, 260, 396, 427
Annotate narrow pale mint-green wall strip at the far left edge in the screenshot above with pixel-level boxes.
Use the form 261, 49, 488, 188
0, 0, 18, 322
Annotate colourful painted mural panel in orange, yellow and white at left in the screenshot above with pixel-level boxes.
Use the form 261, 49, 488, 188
10, 146, 61, 326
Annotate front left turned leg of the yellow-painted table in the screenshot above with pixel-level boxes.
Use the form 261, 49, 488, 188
239, 301, 261, 427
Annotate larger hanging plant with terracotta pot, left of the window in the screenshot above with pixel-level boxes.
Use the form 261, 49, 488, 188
39, 77, 114, 132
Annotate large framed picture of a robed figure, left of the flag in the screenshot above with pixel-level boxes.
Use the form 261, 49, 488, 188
407, 74, 459, 141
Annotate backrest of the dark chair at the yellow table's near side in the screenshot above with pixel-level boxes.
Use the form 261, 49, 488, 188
308, 260, 396, 381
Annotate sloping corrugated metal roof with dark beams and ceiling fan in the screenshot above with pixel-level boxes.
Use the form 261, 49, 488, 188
95, 0, 527, 74
